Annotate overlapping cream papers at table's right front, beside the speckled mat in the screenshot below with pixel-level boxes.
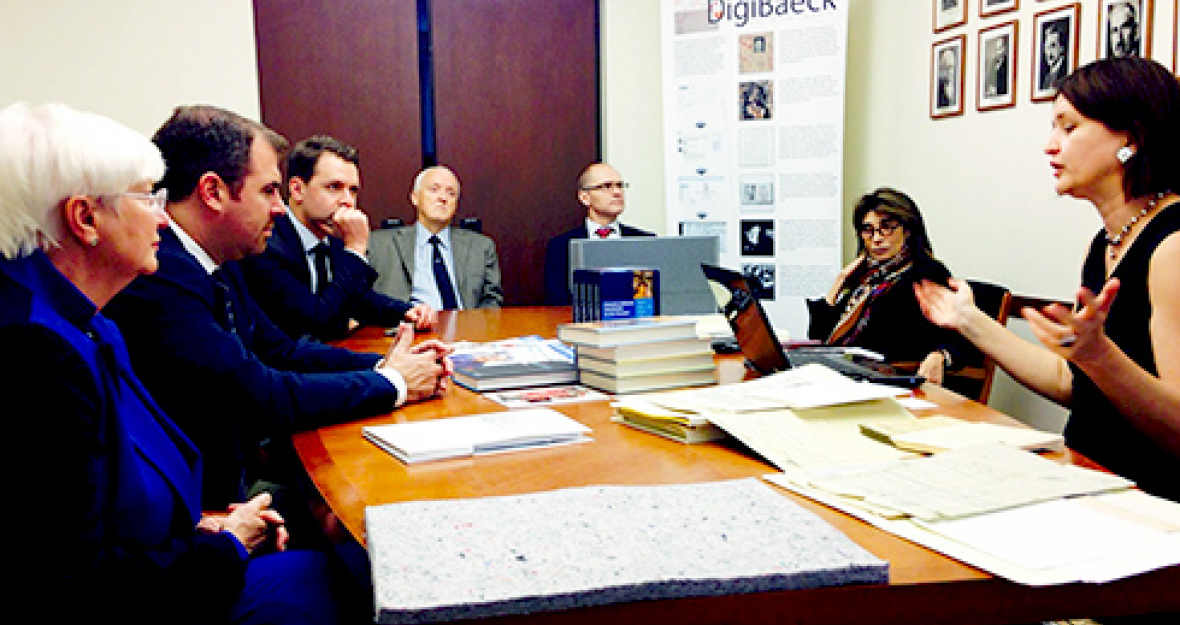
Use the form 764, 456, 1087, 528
766, 445, 1180, 586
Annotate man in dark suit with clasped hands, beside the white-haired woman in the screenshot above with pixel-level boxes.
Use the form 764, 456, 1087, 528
107, 106, 450, 509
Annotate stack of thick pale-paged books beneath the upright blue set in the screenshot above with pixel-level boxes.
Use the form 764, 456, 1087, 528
557, 317, 716, 394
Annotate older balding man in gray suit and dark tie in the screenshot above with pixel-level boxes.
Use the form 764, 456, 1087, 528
368, 165, 504, 310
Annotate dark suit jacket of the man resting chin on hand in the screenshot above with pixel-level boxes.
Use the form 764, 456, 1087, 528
238, 215, 409, 341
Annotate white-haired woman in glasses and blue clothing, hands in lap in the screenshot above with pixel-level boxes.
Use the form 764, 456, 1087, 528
0, 103, 335, 623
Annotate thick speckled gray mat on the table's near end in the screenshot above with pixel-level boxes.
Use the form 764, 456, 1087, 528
366, 479, 889, 624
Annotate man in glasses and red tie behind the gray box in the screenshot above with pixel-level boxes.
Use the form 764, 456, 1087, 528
545, 163, 655, 305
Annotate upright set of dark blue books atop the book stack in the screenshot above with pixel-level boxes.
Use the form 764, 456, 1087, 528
573, 267, 660, 322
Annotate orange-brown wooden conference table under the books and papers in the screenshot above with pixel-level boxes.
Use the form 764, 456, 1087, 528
295, 307, 1180, 625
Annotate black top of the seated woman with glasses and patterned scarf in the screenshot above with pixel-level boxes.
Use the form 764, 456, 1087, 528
807, 257, 963, 366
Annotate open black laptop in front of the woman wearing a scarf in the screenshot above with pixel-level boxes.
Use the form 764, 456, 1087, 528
701, 263, 925, 388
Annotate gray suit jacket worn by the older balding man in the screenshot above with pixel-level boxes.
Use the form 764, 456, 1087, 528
369, 225, 504, 308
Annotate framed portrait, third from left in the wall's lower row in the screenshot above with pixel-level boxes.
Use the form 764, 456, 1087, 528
1029, 2, 1081, 101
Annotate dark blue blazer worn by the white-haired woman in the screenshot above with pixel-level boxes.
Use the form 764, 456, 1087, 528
0, 251, 247, 623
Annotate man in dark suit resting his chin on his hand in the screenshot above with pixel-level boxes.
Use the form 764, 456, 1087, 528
241, 136, 435, 341
